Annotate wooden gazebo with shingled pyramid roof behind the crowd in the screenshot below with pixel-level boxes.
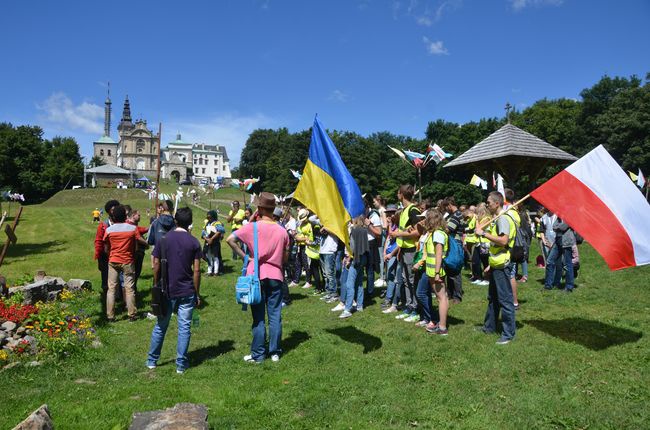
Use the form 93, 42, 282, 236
445, 124, 577, 185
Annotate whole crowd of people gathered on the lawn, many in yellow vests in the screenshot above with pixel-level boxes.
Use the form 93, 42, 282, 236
93, 185, 581, 373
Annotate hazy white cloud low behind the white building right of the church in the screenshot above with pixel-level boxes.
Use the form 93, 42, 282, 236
162, 113, 277, 167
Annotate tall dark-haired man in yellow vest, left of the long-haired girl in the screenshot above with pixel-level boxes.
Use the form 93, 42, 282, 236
390, 185, 420, 319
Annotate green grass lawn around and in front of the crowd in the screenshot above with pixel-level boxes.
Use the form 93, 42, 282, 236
0, 190, 650, 429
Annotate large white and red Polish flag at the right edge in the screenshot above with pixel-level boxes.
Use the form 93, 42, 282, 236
530, 145, 650, 270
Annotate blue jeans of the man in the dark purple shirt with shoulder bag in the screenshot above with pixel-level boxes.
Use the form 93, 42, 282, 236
147, 294, 196, 370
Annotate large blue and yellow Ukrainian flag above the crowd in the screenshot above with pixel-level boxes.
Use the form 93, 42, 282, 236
294, 116, 364, 247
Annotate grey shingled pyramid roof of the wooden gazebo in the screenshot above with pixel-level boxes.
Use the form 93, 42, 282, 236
445, 124, 577, 167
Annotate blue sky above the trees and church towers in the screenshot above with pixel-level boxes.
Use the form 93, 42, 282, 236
0, 0, 650, 165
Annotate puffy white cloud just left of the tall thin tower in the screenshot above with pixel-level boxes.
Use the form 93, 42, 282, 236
36, 92, 104, 134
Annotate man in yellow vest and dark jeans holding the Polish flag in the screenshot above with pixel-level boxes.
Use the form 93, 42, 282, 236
476, 191, 516, 345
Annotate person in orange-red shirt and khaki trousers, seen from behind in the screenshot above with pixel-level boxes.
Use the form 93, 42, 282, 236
104, 205, 147, 321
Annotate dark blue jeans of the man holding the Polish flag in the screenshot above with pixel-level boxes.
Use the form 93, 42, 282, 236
483, 269, 516, 339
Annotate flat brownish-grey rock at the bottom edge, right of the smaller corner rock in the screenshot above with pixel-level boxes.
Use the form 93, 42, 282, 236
129, 403, 208, 430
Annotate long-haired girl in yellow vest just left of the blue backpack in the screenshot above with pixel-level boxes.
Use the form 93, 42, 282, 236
424, 209, 449, 336
